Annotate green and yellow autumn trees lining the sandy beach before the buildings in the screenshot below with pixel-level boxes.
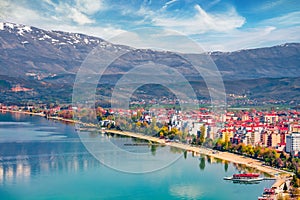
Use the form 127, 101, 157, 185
116, 115, 300, 187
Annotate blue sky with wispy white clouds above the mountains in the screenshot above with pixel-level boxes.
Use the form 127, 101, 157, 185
0, 0, 300, 51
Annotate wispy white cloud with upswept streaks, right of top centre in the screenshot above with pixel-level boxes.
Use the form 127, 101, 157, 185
152, 5, 246, 34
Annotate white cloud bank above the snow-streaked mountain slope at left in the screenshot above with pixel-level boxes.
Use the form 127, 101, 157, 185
0, 0, 124, 39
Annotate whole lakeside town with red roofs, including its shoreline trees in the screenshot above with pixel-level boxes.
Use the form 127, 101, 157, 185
0, 104, 300, 199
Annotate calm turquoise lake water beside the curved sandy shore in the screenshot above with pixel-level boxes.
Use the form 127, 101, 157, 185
0, 114, 273, 200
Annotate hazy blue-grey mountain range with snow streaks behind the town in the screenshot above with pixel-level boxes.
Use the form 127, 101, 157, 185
0, 23, 300, 102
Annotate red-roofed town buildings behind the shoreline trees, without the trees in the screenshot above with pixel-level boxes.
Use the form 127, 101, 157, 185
1, 105, 300, 155
